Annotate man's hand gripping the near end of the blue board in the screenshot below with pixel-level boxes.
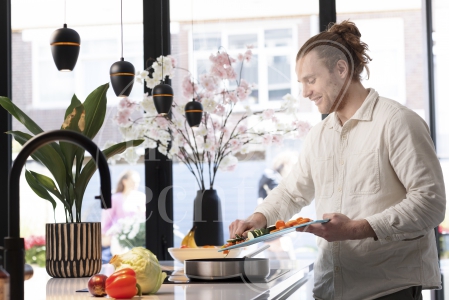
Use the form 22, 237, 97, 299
297, 213, 376, 242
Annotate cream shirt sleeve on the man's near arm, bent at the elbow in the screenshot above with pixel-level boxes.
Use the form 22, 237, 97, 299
366, 109, 446, 243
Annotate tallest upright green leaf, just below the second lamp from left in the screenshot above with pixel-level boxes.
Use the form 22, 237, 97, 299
84, 83, 109, 139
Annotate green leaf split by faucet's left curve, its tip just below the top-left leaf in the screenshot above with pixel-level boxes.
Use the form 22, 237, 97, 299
7, 131, 67, 195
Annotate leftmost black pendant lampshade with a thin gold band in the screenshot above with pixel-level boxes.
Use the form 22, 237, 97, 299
50, 24, 81, 71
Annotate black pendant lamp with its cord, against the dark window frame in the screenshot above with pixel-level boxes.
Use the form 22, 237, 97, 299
153, 0, 173, 115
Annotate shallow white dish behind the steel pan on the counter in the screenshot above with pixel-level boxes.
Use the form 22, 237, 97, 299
168, 247, 242, 263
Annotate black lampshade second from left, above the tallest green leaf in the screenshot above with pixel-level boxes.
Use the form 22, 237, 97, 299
109, 57, 135, 97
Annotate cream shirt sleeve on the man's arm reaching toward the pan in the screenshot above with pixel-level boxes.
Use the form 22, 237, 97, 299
255, 128, 316, 225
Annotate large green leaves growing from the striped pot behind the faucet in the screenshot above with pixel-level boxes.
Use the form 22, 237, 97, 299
0, 83, 143, 222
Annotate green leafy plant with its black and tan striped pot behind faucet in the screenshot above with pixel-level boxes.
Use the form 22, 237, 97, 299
0, 84, 142, 277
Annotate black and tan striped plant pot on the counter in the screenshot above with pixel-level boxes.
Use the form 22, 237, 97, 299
45, 222, 102, 278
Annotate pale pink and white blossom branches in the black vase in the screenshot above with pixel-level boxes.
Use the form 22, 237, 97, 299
115, 47, 310, 191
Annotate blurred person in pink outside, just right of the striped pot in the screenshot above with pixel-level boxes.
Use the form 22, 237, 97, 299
101, 170, 145, 263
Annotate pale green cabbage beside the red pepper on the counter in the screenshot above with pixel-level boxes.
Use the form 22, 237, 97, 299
109, 247, 167, 294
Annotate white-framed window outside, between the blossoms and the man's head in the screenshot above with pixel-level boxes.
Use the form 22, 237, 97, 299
190, 22, 297, 109
